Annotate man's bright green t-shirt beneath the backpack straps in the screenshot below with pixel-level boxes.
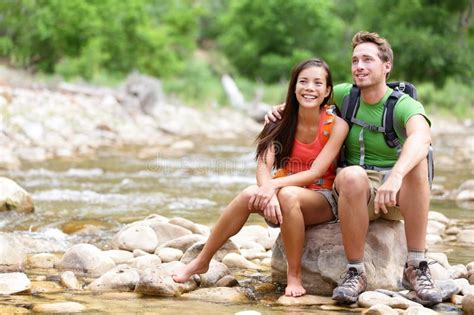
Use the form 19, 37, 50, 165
333, 83, 431, 167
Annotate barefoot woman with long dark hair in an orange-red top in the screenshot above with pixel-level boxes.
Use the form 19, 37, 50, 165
172, 59, 348, 296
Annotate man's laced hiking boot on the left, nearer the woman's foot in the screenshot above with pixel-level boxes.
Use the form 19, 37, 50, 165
332, 267, 367, 304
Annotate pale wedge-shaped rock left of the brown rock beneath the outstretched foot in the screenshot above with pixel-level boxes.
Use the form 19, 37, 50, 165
87, 265, 140, 292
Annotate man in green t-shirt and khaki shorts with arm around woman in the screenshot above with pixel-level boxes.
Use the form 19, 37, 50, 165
267, 32, 442, 304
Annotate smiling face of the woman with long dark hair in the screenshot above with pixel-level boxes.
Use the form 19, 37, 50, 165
295, 66, 331, 108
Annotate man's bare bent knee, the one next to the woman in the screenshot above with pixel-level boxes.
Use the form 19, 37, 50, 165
336, 166, 369, 194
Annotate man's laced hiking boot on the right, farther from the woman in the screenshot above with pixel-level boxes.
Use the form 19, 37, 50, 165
403, 260, 443, 304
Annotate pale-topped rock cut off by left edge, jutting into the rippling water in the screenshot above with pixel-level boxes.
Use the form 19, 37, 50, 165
0, 177, 34, 213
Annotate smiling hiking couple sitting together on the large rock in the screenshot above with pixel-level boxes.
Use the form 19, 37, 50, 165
173, 32, 441, 304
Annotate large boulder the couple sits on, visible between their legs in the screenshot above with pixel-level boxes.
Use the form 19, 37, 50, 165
272, 220, 407, 295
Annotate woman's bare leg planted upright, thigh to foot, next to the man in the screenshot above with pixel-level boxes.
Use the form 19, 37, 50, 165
278, 186, 334, 297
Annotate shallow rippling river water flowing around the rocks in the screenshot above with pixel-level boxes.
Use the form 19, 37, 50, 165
0, 134, 474, 314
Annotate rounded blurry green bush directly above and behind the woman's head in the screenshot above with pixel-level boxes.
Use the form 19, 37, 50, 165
218, 0, 341, 82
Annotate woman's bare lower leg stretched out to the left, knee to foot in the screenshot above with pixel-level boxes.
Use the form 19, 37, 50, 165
172, 186, 258, 283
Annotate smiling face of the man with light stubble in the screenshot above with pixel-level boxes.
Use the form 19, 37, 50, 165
352, 43, 392, 89
